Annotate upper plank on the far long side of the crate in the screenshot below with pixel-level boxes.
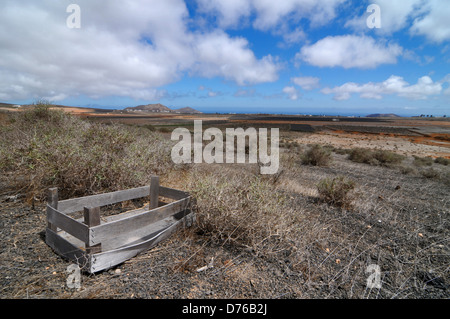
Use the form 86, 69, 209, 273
58, 186, 150, 214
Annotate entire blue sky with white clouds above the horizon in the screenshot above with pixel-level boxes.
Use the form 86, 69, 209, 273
0, 0, 450, 116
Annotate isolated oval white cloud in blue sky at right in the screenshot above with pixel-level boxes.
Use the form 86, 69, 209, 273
296, 35, 403, 69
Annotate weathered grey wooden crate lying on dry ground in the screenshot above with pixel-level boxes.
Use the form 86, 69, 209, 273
45, 176, 195, 273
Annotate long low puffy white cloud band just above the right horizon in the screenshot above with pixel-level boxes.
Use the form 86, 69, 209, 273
321, 75, 442, 101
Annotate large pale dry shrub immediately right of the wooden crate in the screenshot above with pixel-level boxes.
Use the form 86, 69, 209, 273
188, 171, 295, 254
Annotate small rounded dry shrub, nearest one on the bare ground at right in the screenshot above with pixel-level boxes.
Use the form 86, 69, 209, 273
317, 176, 355, 209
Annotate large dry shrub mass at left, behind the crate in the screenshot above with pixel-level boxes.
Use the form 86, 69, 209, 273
0, 104, 174, 198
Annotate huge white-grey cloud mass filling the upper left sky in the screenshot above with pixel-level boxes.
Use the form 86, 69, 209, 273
0, 0, 279, 100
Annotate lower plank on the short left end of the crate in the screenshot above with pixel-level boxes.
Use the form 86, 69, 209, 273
45, 228, 90, 270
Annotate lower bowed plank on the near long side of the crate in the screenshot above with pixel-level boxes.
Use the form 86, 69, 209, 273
90, 215, 188, 273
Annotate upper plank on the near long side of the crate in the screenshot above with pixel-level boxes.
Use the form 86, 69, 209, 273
89, 197, 190, 245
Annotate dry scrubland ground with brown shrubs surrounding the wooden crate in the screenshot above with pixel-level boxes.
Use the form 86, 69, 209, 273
0, 105, 450, 299
